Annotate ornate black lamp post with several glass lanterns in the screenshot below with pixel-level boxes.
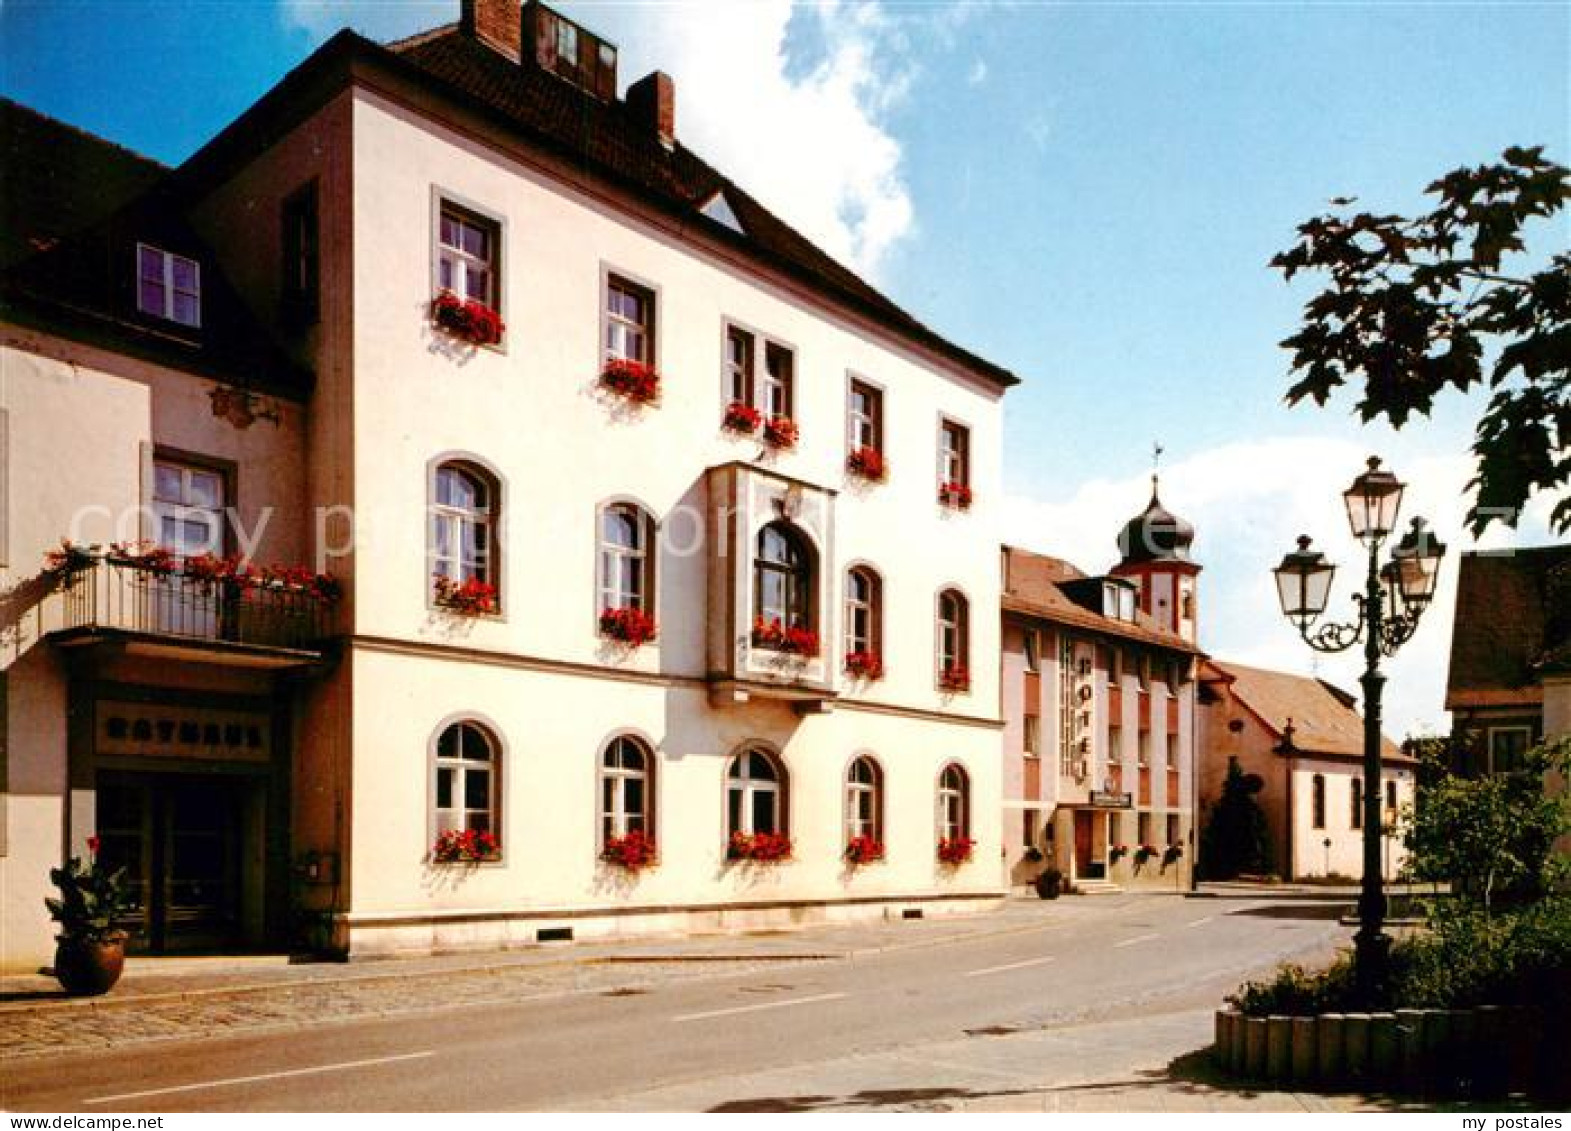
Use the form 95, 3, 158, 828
1273, 459, 1445, 1001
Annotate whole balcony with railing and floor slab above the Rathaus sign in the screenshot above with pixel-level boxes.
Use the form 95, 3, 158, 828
50, 551, 336, 668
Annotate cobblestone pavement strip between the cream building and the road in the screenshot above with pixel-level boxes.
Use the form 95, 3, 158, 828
0, 958, 812, 1060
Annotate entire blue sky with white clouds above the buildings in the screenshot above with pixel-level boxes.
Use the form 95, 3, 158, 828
0, 0, 1571, 732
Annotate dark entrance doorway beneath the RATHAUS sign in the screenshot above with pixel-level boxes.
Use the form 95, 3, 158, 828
97, 771, 251, 953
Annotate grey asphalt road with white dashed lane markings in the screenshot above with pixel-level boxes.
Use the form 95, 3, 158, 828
0, 897, 1348, 1114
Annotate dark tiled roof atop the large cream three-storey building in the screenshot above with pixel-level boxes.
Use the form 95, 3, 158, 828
386, 27, 1018, 386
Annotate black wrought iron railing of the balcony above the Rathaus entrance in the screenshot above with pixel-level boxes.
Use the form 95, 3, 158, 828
57, 555, 336, 652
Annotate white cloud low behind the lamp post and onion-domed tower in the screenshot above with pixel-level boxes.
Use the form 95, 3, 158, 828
1005, 438, 1549, 738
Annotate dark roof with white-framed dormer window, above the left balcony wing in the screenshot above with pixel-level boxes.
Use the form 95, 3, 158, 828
0, 102, 311, 396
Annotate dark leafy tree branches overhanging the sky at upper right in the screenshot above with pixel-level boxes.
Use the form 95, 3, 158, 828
1271, 146, 1571, 534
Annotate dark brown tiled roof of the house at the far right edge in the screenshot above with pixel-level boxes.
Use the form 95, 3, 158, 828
1445, 544, 1571, 710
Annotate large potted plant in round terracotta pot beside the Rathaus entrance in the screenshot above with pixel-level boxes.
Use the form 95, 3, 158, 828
44, 837, 130, 997
